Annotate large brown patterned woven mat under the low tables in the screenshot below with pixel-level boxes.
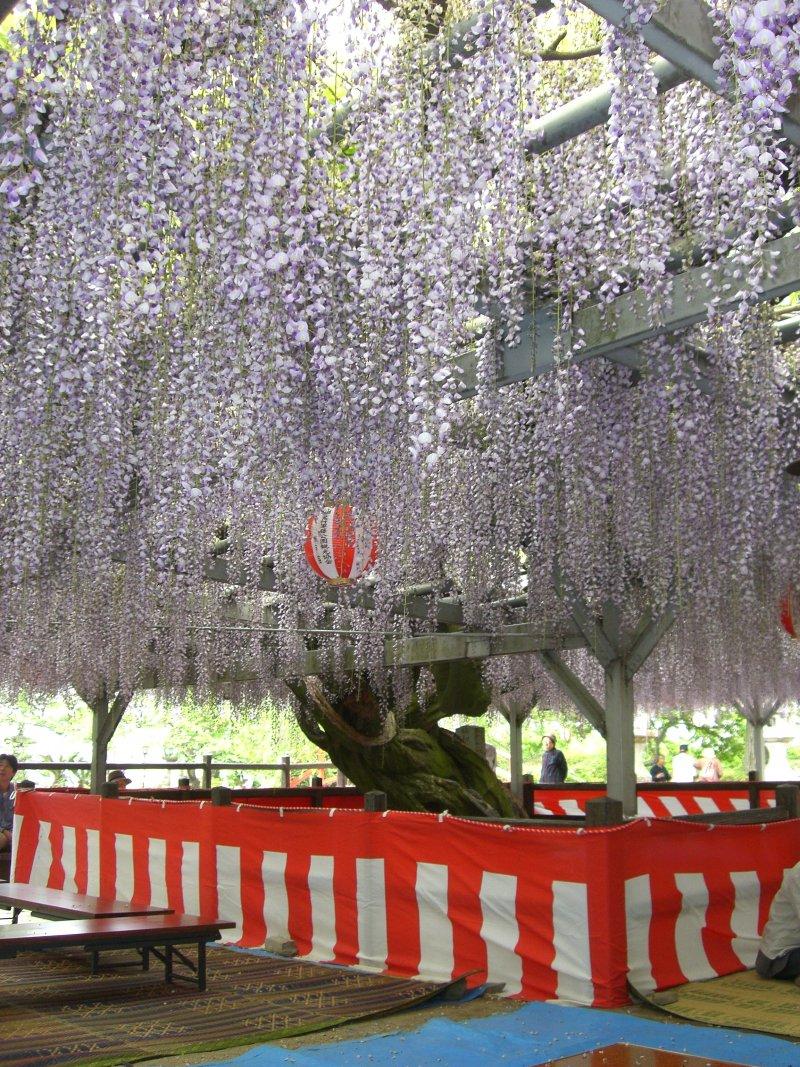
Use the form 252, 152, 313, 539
0, 950, 454, 1067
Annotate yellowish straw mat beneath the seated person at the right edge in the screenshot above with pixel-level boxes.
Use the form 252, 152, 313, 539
636, 971, 800, 1038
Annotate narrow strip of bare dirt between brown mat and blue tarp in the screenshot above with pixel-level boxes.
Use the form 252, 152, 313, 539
145, 996, 721, 1067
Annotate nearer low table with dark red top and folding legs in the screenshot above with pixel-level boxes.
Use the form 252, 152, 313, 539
0, 914, 236, 992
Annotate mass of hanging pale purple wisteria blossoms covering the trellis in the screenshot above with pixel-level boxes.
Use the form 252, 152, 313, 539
0, 0, 800, 721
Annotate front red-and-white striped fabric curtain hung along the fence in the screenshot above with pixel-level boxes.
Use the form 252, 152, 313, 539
16, 791, 800, 1006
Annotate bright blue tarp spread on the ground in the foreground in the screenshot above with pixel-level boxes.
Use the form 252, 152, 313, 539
204, 1003, 800, 1067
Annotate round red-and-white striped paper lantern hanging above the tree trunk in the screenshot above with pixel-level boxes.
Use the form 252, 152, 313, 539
304, 504, 378, 586
